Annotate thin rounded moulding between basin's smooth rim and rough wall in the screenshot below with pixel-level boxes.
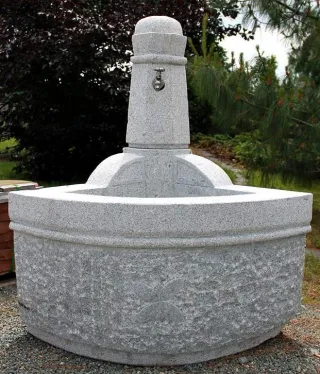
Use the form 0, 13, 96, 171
10, 222, 311, 249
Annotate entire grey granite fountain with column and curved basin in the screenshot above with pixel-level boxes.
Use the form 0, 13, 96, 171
9, 17, 312, 365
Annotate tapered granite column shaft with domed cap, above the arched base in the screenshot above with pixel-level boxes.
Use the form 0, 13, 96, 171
126, 17, 190, 148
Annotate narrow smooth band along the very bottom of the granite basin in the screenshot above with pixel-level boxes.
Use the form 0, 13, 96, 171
26, 325, 283, 366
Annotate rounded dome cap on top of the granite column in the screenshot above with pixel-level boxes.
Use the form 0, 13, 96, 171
134, 16, 183, 35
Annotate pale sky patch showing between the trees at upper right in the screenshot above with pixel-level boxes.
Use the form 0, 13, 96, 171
221, 22, 290, 78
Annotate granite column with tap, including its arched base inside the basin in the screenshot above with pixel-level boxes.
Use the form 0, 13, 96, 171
88, 16, 231, 197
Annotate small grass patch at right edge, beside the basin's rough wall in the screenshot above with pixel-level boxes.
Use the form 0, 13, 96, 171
302, 253, 320, 306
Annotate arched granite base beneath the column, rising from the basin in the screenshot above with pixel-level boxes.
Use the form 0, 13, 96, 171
88, 148, 232, 197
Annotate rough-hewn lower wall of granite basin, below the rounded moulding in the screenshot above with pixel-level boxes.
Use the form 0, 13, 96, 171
15, 234, 304, 365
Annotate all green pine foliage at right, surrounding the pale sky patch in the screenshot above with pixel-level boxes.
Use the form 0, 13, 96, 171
190, 0, 320, 180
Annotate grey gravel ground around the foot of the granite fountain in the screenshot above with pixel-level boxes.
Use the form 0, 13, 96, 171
0, 284, 320, 374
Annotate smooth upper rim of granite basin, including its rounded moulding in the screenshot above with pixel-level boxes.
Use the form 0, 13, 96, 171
9, 185, 312, 248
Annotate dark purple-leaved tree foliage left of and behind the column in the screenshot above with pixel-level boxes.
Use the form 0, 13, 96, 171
0, 0, 246, 180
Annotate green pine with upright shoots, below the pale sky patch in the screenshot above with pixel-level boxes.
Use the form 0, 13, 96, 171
189, 18, 320, 179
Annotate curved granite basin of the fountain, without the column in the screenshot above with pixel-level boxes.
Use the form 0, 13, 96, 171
9, 184, 312, 365
